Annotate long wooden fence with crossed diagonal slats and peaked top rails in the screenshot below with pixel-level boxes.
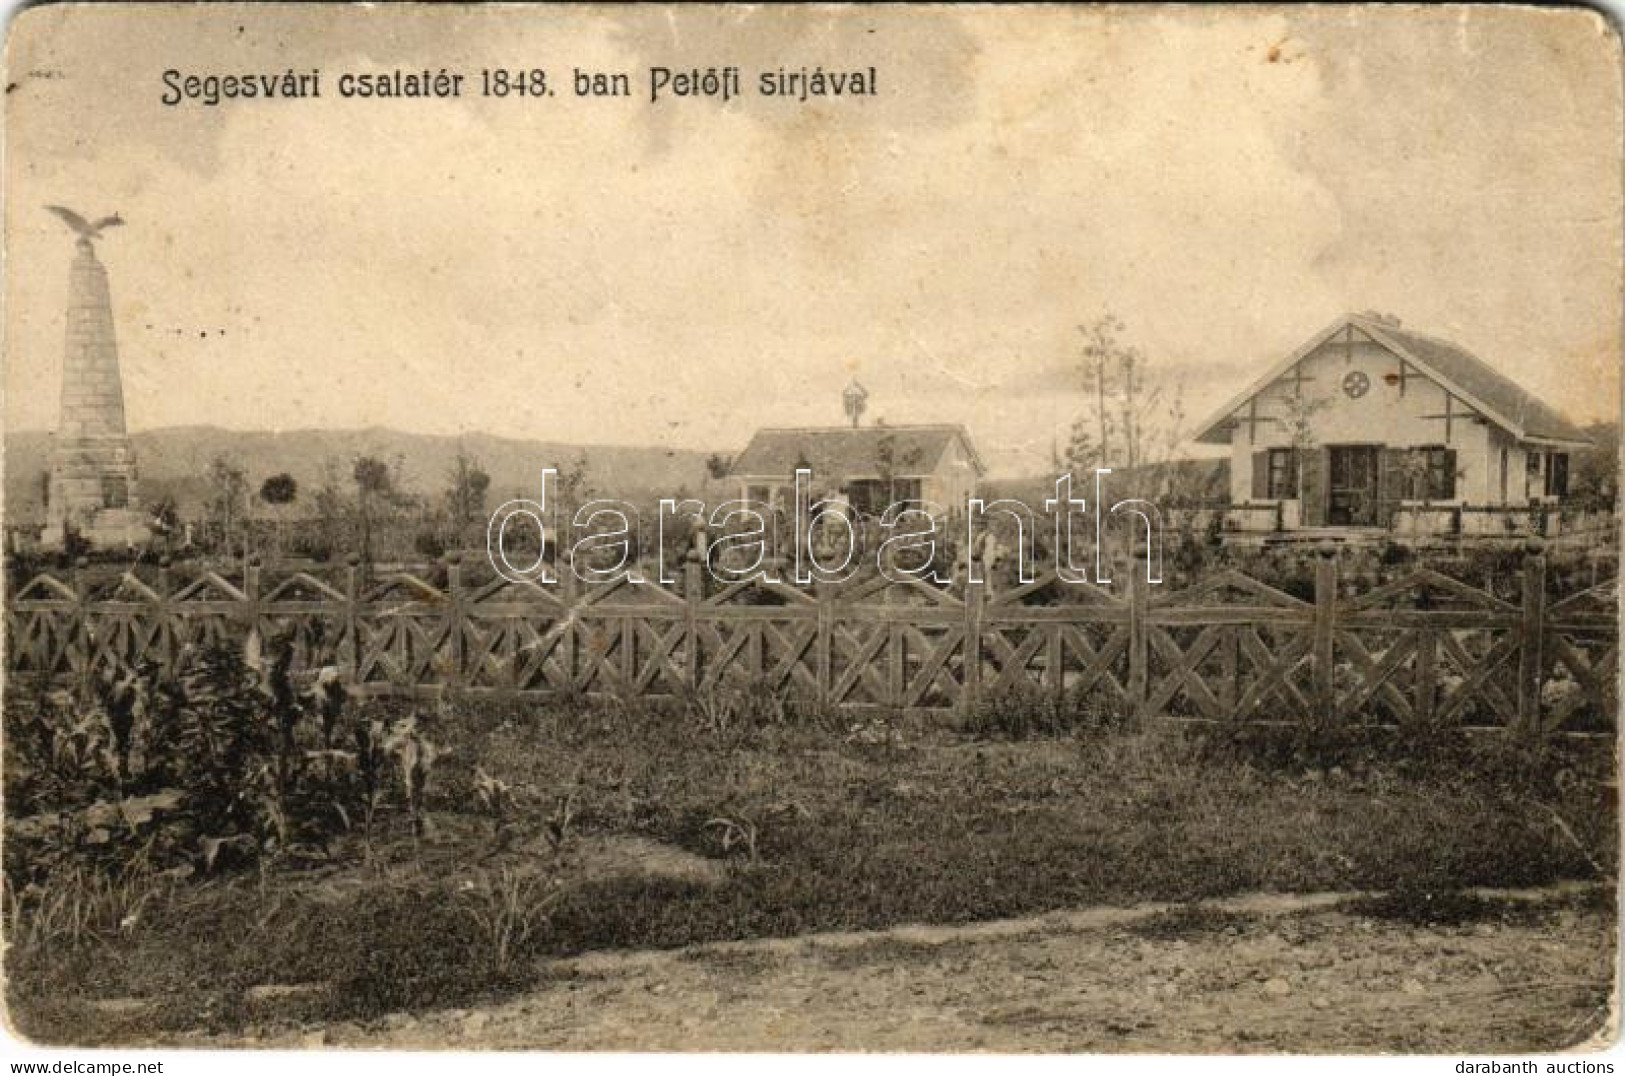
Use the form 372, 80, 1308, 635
5, 549, 1619, 733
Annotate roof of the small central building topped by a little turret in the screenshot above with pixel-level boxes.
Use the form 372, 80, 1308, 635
728, 424, 986, 478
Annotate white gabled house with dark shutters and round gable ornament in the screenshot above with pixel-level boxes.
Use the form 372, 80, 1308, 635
1196, 314, 1591, 533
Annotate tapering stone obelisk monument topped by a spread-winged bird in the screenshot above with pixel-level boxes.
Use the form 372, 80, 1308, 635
44, 206, 150, 548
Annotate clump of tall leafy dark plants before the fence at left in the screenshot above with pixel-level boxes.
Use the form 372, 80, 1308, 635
5, 639, 451, 892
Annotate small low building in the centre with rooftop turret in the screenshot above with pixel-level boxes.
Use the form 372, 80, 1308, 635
728, 426, 986, 515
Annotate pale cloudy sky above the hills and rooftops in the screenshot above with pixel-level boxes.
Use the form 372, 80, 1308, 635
5, 5, 1622, 471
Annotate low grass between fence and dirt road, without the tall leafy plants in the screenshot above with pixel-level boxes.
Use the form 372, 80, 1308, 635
7, 702, 1617, 1043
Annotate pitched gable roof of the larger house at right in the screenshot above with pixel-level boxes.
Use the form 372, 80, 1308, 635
1194, 314, 1591, 445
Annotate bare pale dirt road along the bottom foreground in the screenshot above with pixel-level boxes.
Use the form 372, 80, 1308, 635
225, 891, 1614, 1053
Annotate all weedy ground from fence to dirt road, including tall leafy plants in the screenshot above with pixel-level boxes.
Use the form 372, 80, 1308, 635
3, 627, 1617, 1043
